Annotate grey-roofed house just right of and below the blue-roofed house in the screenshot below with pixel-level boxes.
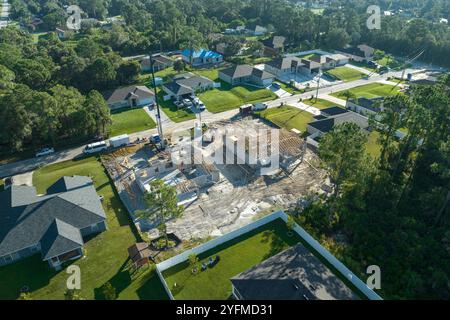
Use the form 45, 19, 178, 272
219, 64, 275, 87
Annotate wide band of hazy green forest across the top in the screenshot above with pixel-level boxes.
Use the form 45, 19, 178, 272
8, 0, 450, 66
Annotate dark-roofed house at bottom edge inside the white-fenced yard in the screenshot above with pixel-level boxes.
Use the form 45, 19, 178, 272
230, 244, 359, 300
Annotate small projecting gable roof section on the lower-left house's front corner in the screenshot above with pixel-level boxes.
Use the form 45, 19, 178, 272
41, 218, 83, 261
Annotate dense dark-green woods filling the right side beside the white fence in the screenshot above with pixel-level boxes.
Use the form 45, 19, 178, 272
299, 81, 450, 299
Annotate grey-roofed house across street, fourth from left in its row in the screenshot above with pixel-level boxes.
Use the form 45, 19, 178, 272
264, 57, 321, 77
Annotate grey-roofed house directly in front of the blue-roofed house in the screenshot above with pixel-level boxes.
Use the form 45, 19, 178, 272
162, 72, 214, 100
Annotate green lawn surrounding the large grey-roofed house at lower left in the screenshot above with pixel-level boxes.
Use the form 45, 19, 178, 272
0, 157, 167, 300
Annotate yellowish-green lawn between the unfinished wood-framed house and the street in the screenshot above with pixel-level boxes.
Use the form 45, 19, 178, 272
255, 106, 313, 132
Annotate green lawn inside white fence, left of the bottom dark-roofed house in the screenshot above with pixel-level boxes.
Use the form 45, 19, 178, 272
163, 219, 300, 300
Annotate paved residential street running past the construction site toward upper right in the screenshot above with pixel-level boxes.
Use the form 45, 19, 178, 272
0, 72, 401, 178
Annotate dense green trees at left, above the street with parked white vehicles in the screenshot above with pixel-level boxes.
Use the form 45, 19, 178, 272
0, 27, 123, 151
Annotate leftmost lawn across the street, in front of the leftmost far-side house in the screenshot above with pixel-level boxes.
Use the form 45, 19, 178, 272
109, 108, 156, 136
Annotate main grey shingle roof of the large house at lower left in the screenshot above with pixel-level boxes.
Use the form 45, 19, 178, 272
0, 177, 106, 257
